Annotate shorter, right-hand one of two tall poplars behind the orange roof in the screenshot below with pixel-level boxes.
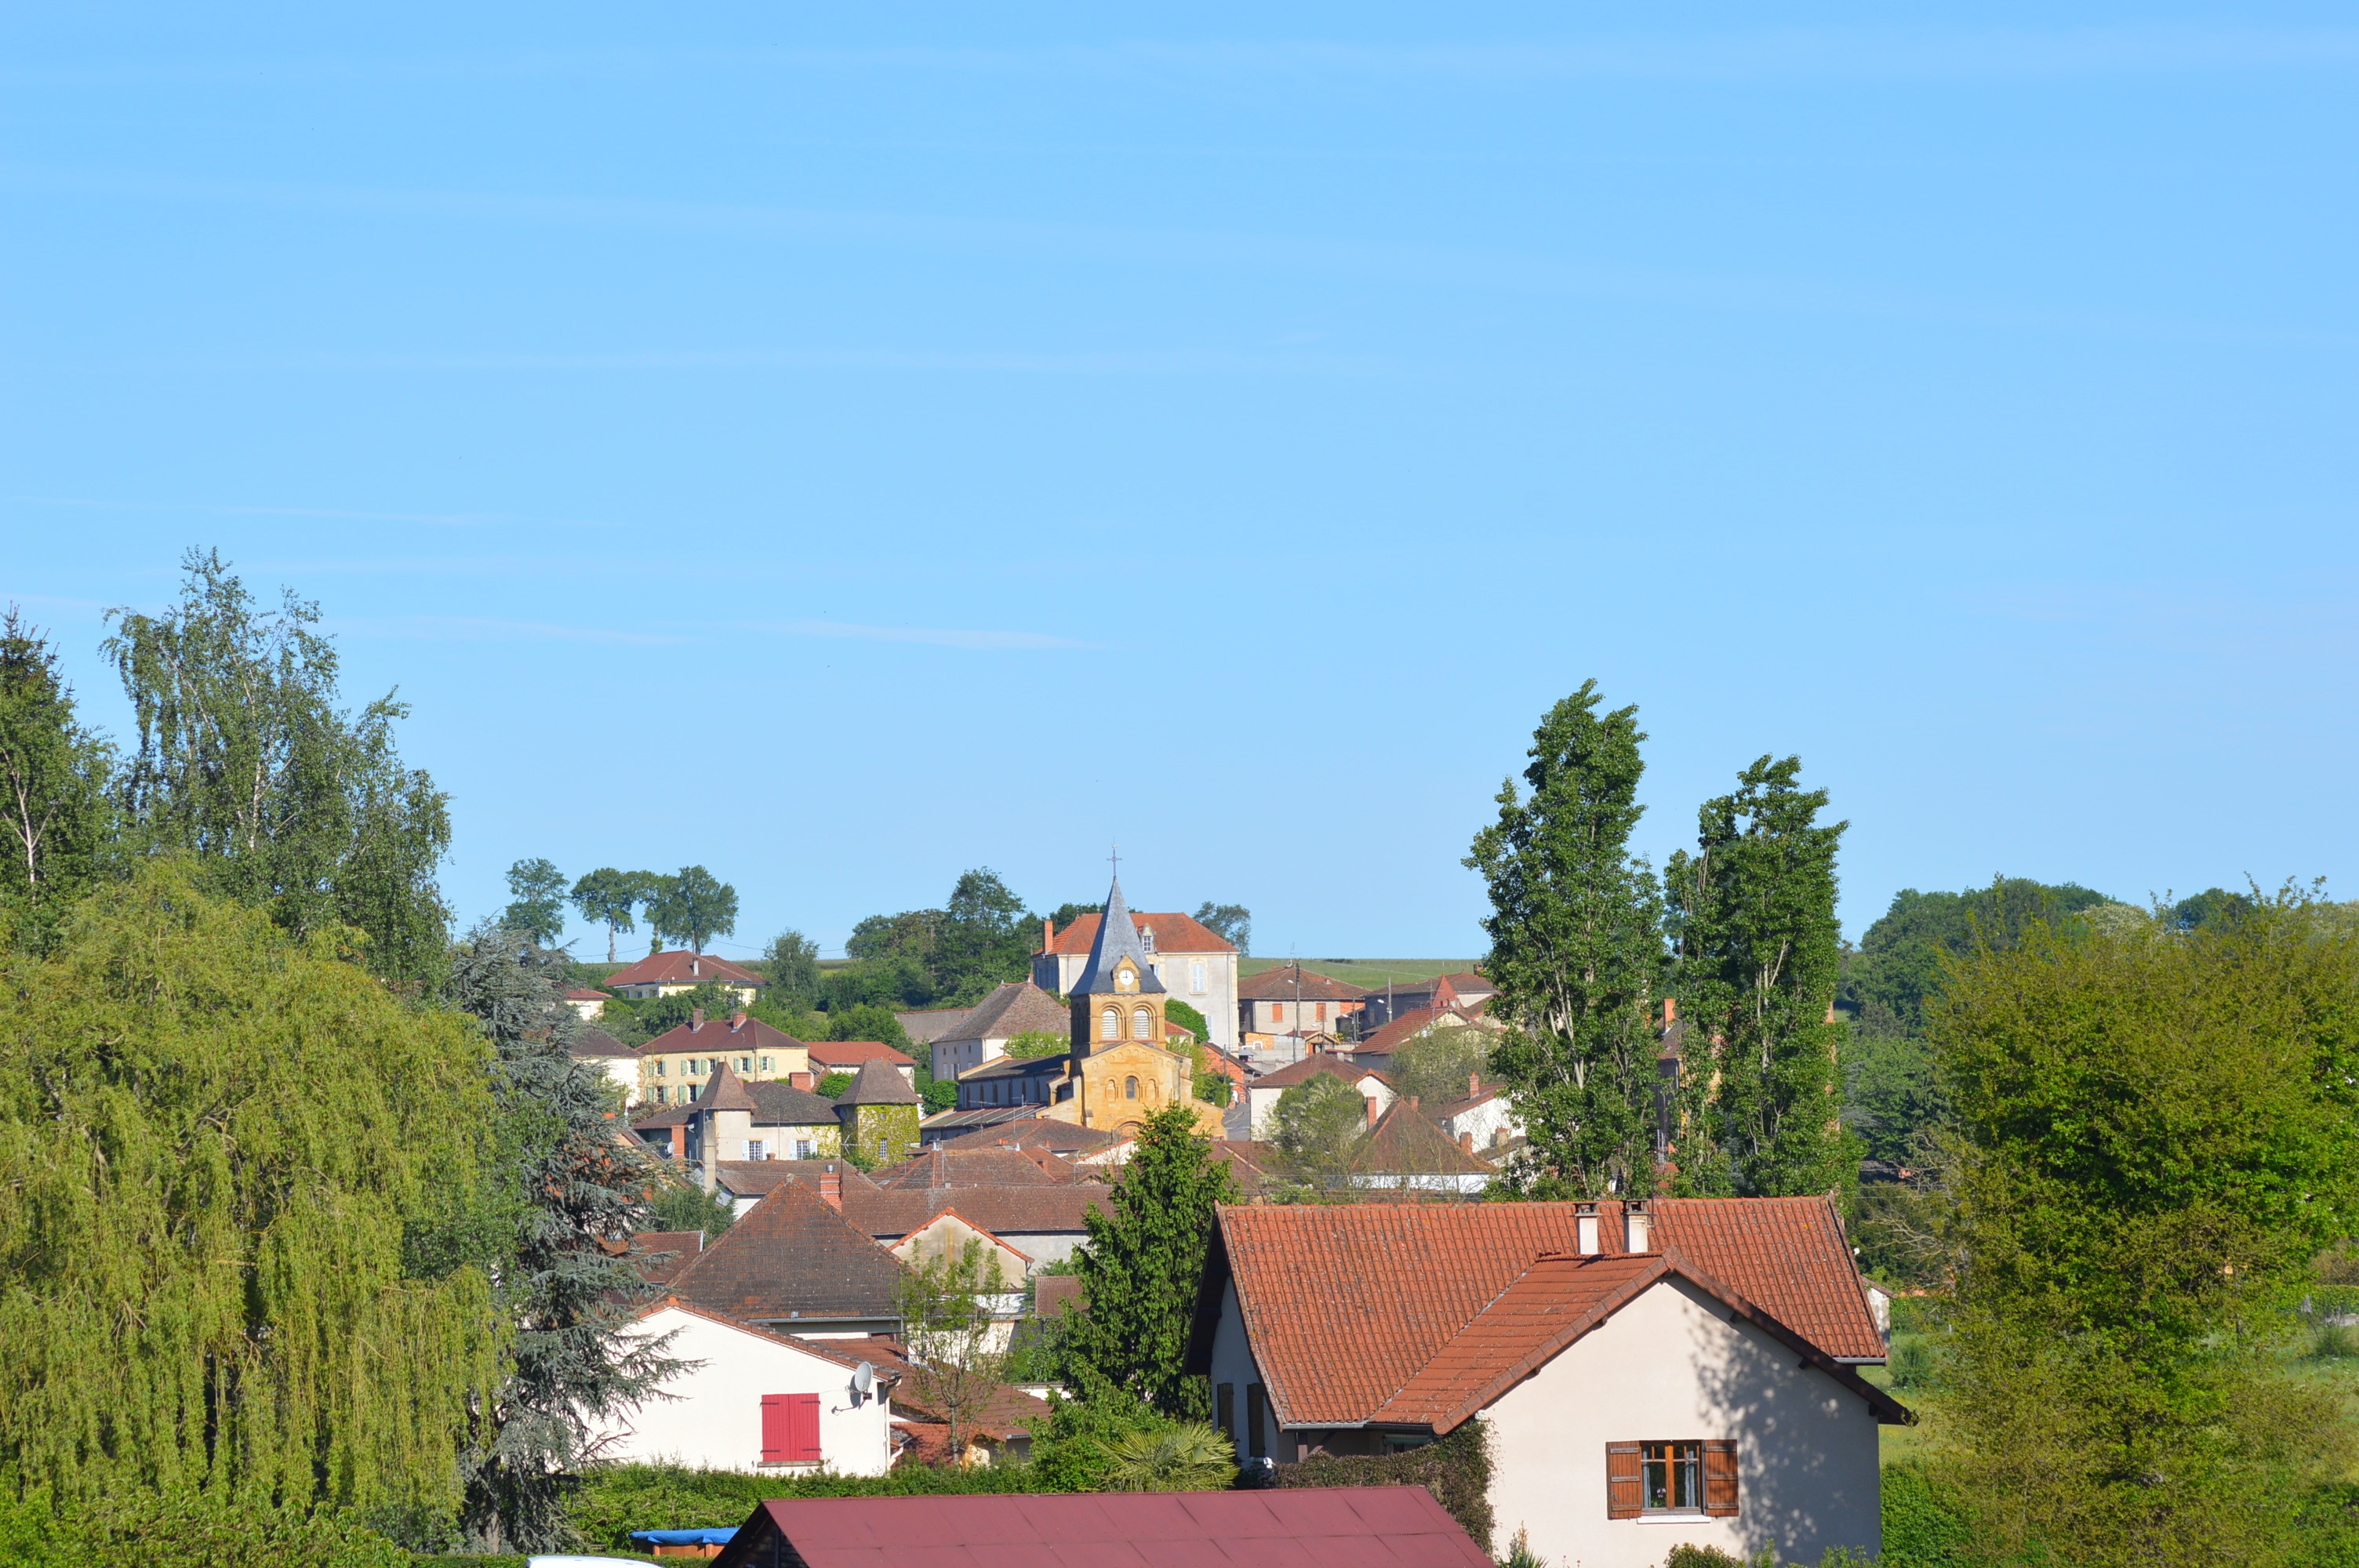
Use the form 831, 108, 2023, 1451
1663, 757, 1856, 1198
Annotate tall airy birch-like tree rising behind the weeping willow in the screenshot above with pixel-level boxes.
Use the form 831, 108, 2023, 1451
106, 550, 451, 985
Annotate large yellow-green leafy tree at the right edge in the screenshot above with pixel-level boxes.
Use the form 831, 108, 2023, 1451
1930, 891, 2359, 1568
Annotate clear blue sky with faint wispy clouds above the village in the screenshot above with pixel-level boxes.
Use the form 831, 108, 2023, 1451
0, 5, 2359, 957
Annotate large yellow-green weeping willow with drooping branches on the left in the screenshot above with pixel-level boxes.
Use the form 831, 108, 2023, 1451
0, 863, 505, 1514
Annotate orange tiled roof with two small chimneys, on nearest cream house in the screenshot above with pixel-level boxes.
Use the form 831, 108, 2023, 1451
1189, 1198, 1906, 1434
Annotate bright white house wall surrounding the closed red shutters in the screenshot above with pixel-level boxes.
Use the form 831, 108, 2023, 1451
604, 1306, 892, 1476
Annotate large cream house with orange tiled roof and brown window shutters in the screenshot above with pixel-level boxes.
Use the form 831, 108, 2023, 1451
1187, 1198, 1910, 1568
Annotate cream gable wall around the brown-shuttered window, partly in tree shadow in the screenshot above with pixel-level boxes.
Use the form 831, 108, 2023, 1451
1486, 1280, 1882, 1568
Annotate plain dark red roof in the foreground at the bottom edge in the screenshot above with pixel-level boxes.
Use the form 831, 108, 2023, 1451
712, 1486, 1491, 1568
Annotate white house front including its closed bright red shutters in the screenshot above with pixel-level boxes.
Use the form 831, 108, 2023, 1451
599, 1297, 894, 1476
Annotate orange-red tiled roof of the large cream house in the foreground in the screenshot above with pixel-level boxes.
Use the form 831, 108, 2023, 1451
1198, 1198, 1885, 1427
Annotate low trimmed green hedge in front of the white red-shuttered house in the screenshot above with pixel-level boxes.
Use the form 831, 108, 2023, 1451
566, 1465, 1042, 1552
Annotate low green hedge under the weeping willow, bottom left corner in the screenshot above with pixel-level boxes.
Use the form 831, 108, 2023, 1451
0, 1490, 410, 1568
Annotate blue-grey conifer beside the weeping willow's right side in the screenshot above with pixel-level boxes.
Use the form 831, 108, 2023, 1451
449, 924, 677, 1552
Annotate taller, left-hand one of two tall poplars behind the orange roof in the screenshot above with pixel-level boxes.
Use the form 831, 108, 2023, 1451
1465, 681, 1663, 1198
